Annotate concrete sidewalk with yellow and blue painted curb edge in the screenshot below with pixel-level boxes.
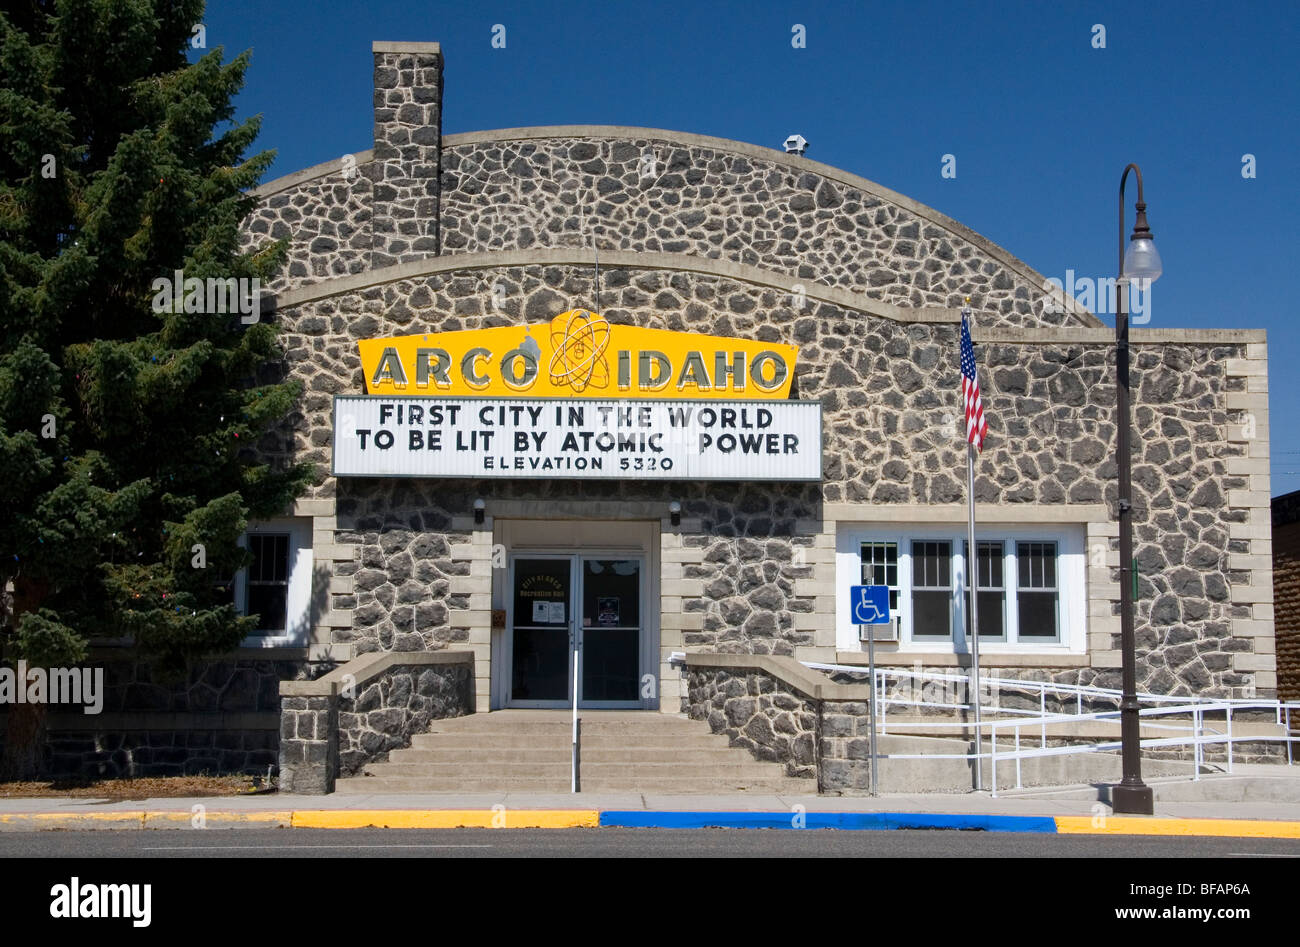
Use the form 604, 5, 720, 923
0, 780, 1300, 839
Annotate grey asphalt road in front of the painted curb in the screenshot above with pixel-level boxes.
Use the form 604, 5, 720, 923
0, 829, 1300, 860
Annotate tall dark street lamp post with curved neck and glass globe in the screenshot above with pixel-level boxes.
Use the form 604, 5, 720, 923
1110, 164, 1161, 816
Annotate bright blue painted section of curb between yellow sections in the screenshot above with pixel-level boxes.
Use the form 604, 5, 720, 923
601, 809, 1057, 835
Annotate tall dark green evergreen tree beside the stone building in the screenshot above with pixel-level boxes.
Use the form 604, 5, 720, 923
0, 0, 313, 777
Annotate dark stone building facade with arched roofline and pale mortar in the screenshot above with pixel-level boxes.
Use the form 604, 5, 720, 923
27, 43, 1278, 766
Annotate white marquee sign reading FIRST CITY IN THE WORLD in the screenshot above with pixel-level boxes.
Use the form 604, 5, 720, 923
333, 395, 822, 480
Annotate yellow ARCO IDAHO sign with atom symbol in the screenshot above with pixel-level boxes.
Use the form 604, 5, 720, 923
358, 310, 798, 399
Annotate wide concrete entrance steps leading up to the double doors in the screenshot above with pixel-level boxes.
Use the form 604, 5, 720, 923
335, 710, 816, 795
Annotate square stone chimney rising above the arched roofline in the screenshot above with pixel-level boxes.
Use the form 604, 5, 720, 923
369, 43, 442, 267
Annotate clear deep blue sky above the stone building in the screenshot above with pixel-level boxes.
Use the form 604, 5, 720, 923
204, 0, 1300, 496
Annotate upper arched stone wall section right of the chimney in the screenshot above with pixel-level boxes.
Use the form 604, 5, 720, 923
442, 137, 1095, 325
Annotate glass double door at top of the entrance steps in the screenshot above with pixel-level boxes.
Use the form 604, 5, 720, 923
508, 554, 645, 708
